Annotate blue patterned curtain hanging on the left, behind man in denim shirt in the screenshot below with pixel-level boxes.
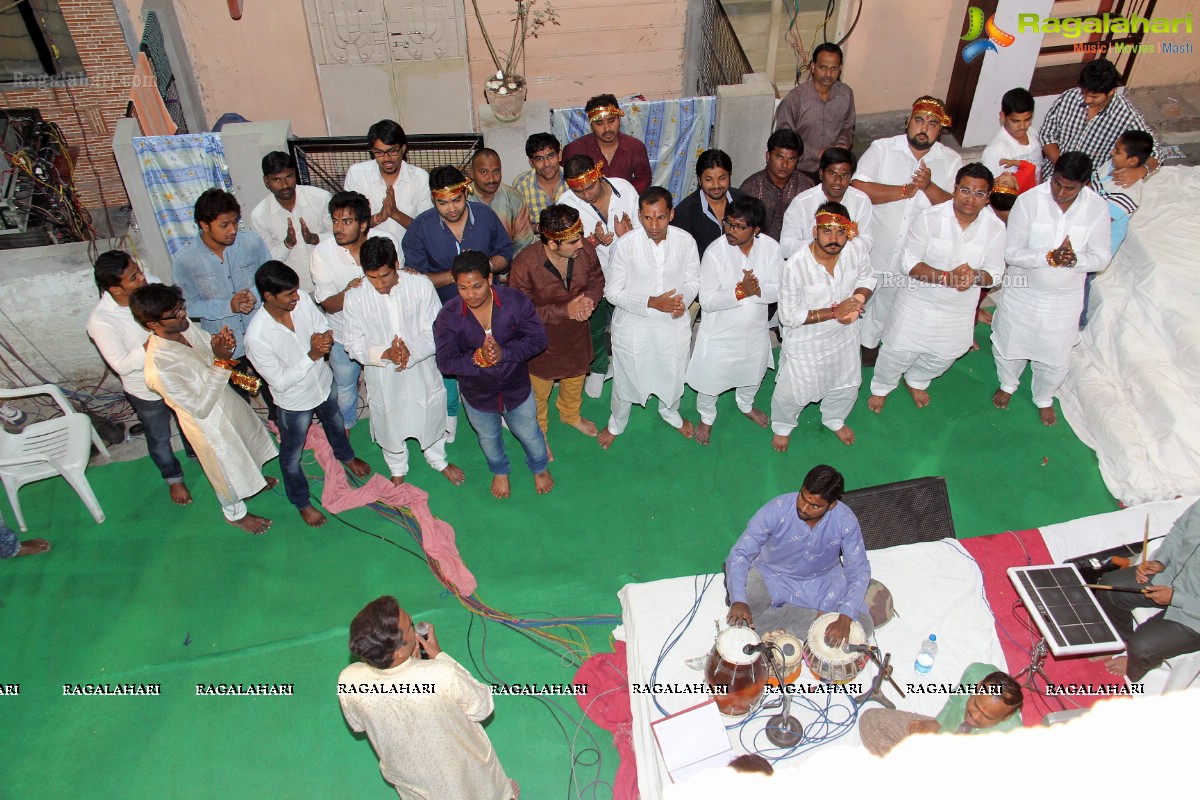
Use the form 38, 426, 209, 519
133, 133, 233, 255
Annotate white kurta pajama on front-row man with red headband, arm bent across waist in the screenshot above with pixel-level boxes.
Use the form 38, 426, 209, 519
770, 241, 875, 437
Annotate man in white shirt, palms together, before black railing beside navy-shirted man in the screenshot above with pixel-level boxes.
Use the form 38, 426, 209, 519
344, 120, 433, 242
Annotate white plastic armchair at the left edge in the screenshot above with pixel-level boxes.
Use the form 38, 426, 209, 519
0, 384, 108, 531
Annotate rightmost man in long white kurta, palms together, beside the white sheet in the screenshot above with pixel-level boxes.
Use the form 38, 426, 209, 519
991, 152, 1111, 425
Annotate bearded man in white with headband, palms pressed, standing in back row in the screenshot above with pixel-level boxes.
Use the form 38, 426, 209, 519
854, 97, 962, 348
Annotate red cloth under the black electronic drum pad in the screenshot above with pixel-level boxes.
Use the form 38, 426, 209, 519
959, 530, 1123, 726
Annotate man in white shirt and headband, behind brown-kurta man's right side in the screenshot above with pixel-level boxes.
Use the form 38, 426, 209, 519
562, 155, 640, 397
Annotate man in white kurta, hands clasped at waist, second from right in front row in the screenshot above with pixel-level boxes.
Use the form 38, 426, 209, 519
866, 164, 1004, 414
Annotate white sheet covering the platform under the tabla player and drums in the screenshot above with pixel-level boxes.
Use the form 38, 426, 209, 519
619, 540, 1003, 800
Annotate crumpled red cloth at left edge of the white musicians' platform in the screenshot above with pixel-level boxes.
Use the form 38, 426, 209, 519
574, 642, 640, 800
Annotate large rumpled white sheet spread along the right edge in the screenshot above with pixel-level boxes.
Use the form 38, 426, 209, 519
1058, 167, 1200, 505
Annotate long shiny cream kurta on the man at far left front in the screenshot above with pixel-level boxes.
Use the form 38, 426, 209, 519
145, 325, 278, 522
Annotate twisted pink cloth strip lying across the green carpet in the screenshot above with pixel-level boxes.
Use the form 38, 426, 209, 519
292, 425, 479, 597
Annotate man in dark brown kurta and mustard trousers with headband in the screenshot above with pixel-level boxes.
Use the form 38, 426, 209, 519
509, 204, 604, 437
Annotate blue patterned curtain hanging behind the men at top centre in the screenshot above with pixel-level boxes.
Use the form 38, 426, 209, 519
551, 97, 716, 203
